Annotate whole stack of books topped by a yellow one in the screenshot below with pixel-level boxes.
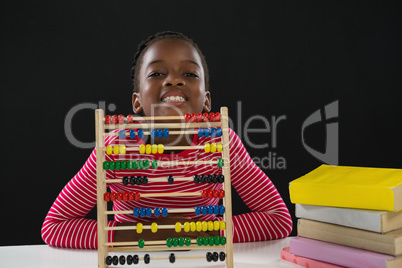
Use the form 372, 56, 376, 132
281, 165, 402, 268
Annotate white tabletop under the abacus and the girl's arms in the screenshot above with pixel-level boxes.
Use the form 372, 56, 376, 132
0, 238, 301, 268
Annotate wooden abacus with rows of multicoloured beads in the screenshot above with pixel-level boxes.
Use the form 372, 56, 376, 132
95, 107, 233, 268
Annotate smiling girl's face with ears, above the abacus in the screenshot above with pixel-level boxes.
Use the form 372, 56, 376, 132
133, 39, 211, 116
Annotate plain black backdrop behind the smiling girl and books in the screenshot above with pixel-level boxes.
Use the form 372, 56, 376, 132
0, 0, 402, 245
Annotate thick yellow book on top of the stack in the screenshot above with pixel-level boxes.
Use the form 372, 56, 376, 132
289, 165, 402, 211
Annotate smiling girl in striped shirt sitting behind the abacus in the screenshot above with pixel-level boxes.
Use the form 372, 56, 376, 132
42, 32, 292, 248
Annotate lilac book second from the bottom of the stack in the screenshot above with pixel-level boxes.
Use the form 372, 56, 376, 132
290, 236, 402, 268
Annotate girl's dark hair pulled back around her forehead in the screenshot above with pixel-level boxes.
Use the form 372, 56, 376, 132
131, 31, 209, 92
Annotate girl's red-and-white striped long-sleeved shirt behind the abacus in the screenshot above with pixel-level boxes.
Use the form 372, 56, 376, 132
42, 130, 292, 249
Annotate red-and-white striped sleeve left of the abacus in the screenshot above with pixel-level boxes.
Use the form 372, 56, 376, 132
42, 149, 117, 249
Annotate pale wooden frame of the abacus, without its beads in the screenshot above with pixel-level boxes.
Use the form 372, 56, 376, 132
95, 107, 233, 268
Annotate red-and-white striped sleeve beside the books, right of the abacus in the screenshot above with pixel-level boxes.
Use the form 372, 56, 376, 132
229, 130, 292, 242
